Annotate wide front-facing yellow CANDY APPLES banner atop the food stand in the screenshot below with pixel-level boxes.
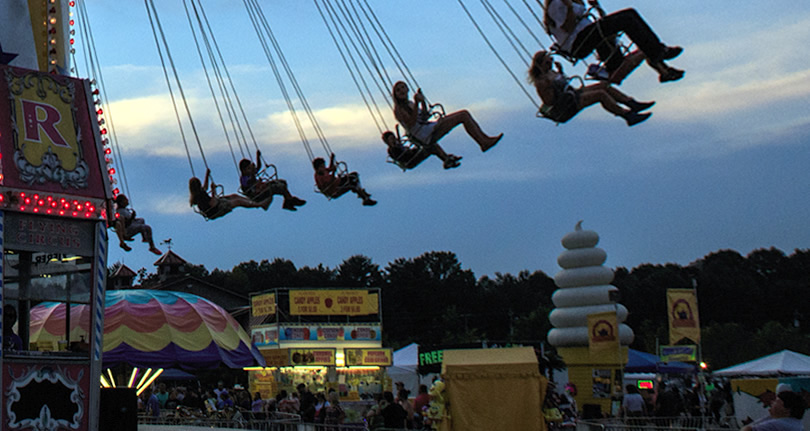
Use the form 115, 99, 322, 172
290, 289, 378, 316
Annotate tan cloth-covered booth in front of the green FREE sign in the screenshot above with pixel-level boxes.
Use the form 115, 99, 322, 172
440, 347, 548, 431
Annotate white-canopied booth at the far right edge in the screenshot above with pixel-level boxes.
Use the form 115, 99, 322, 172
712, 350, 810, 429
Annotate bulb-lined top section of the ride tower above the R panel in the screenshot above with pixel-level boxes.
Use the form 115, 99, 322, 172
0, 0, 70, 72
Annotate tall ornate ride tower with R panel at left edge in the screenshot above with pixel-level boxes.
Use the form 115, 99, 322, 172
0, 0, 114, 431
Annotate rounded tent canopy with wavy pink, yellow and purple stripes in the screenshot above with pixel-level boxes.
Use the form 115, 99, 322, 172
30, 289, 265, 370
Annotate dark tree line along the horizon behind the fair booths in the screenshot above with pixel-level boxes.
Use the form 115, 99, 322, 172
129, 248, 810, 369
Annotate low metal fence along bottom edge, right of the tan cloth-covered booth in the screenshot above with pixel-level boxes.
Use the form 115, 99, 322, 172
577, 416, 740, 431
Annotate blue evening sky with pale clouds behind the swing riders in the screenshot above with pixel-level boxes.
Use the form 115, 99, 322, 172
78, 0, 810, 277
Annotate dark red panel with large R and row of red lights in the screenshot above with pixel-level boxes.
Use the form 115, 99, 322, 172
0, 66, 114, 218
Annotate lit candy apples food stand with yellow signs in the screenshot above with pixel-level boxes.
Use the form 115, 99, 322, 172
249, 288, 393, 418
